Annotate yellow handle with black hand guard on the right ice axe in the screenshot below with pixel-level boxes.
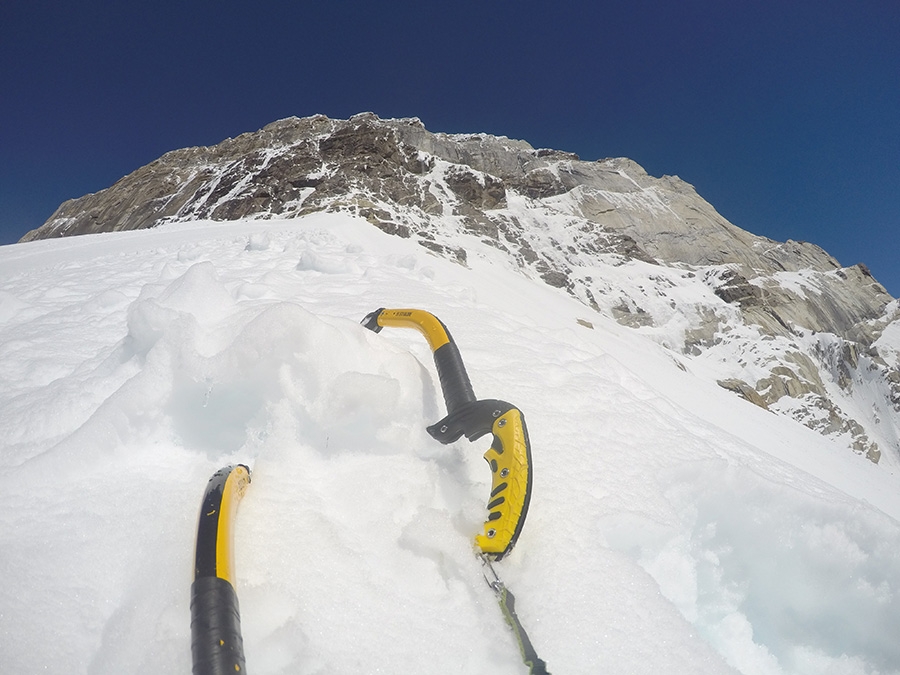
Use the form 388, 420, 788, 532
428, 399, 531, 560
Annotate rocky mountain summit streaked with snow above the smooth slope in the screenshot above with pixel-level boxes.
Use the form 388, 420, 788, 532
23, 113, 900, 465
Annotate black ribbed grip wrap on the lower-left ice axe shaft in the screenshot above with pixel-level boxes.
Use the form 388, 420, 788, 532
191, 577, 246, 675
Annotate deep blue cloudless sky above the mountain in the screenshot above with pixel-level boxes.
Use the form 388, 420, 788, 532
0, 0, 900, 296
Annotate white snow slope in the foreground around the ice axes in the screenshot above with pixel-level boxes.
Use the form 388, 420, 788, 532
0, 215, 900, 675
